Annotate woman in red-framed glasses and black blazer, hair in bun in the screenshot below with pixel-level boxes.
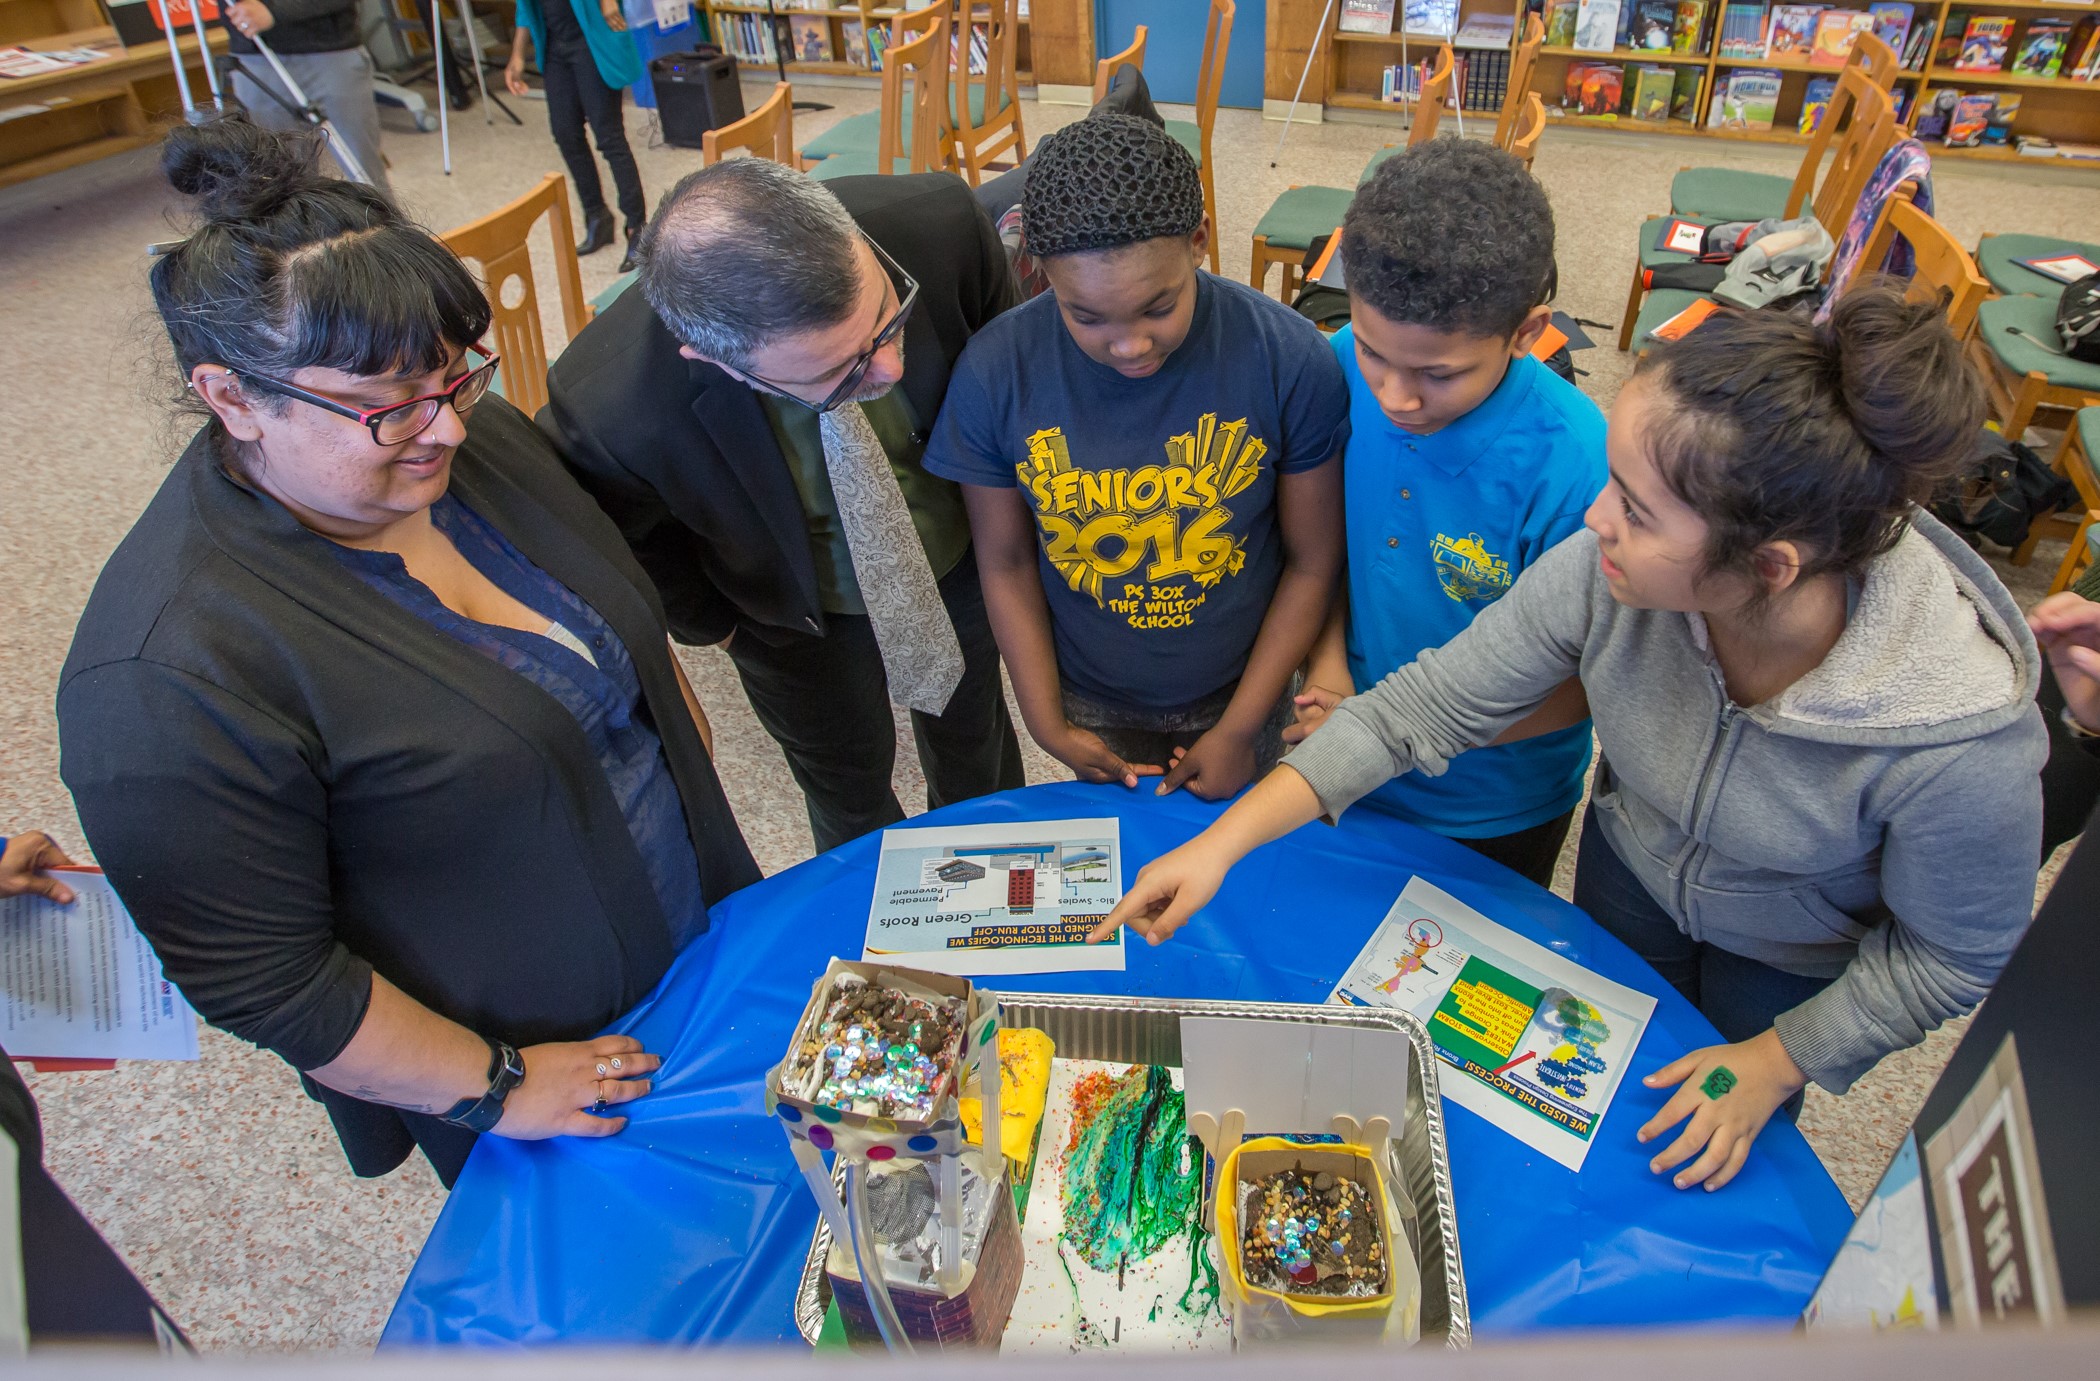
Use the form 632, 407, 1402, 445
59, 120, 758, 1184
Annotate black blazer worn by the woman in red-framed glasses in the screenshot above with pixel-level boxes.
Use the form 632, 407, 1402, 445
59, 397, 758, 1175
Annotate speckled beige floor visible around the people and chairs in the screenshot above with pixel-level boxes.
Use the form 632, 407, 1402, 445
0, 67, 2100, 1350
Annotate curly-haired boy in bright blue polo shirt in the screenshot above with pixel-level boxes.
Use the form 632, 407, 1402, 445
1287, 139, 1607, 886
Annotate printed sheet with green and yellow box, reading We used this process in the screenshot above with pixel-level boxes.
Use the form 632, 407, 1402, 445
1329, 877, 1655, 1171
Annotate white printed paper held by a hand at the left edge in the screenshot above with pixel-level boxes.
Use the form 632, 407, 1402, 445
0, 869, 197, 1060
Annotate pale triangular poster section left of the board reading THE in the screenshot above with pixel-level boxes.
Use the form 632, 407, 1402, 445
1802, 1135, 1940, 1331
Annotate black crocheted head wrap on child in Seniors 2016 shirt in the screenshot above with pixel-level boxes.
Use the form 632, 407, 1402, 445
1021, 111, 1203, 258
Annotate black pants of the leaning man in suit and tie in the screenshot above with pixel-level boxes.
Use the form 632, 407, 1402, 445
729, 552, 1027, 852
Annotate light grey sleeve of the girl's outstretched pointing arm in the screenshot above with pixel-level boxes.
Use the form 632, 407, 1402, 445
1285, 531, 1611, 816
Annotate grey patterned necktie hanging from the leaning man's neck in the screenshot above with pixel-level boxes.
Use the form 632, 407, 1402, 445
819, 403, 962, 714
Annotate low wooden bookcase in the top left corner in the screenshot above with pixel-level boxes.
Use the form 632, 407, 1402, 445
0, 0, 225, 187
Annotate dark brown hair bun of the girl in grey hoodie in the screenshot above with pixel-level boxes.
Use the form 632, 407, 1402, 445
1821, 283, 1985, 502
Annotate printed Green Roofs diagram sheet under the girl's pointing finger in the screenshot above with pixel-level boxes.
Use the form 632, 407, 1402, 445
861, 819, 1124, 978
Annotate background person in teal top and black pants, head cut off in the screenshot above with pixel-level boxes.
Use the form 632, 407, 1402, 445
504, 0, 649, 273
